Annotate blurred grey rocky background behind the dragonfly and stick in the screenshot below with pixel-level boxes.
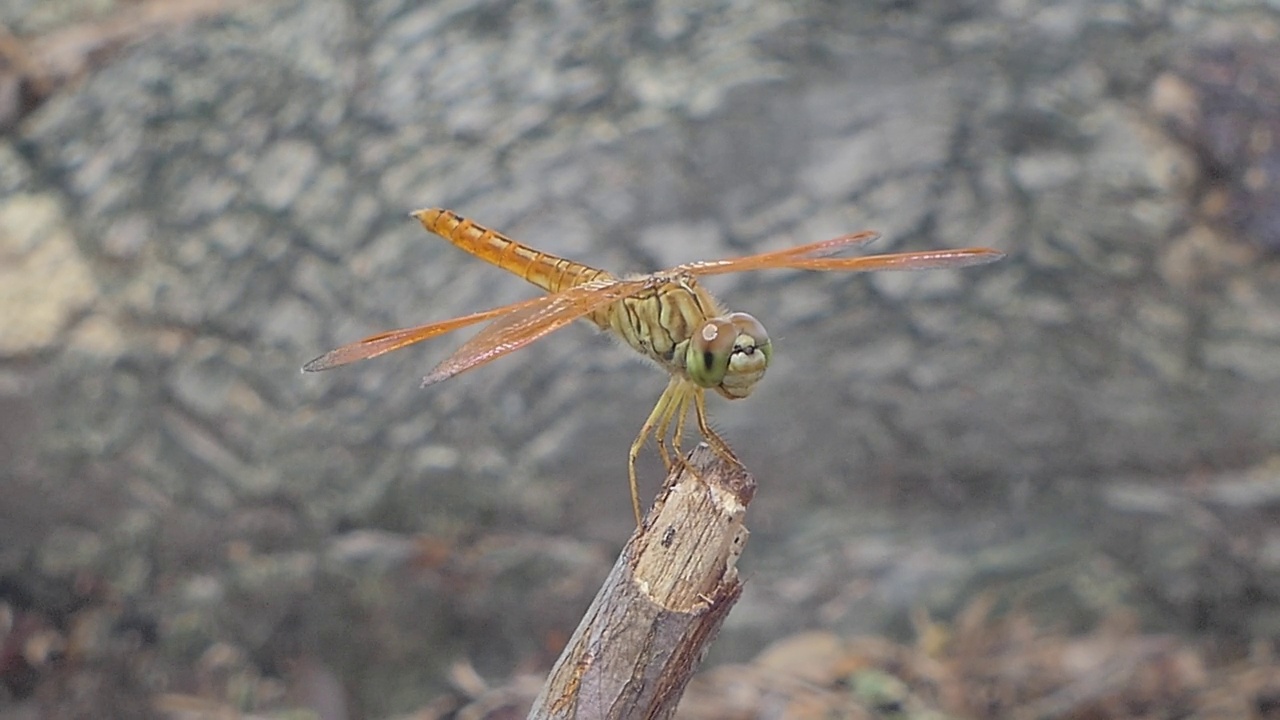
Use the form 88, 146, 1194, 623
0, 0, 1280, 720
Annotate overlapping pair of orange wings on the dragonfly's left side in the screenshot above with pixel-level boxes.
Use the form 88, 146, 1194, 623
302, 278, 649, 386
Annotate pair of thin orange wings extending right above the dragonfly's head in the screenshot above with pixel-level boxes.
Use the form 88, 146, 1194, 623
676, 231, 1005, 275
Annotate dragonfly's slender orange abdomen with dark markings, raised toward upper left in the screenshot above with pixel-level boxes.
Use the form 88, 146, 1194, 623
413, 209, 613, 292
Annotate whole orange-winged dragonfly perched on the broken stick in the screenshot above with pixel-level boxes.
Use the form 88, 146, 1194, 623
302, 209, 1004, 525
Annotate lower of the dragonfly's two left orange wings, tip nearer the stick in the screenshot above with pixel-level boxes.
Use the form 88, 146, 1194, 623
422, 278, 649, 387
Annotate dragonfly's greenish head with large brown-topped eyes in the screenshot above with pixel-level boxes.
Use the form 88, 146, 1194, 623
685, 313, 773, 400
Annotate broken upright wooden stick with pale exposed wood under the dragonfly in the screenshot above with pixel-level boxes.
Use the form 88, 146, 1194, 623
529, 445, 755, 720
